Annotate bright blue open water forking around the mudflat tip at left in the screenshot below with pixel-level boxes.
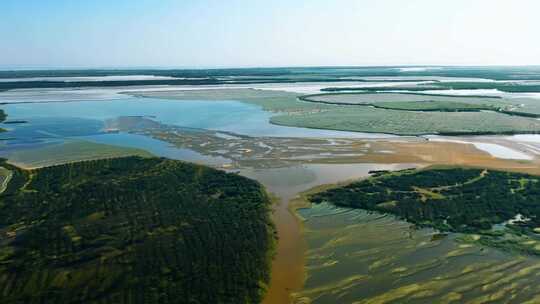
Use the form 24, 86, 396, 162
0, 97, 394, 164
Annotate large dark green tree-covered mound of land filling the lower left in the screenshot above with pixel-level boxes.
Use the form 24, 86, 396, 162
0, 157, 275, 303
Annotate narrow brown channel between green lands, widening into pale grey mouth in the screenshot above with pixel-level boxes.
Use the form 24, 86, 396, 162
240, 164, 416, 304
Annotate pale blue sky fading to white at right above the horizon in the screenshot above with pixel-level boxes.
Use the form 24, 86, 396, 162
0, 0, 540, 68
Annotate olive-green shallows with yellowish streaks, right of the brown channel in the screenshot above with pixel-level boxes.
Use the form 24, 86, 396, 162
294, 204, 540, 304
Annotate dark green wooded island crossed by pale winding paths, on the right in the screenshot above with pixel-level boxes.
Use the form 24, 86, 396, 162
309, 168, 540, 255
